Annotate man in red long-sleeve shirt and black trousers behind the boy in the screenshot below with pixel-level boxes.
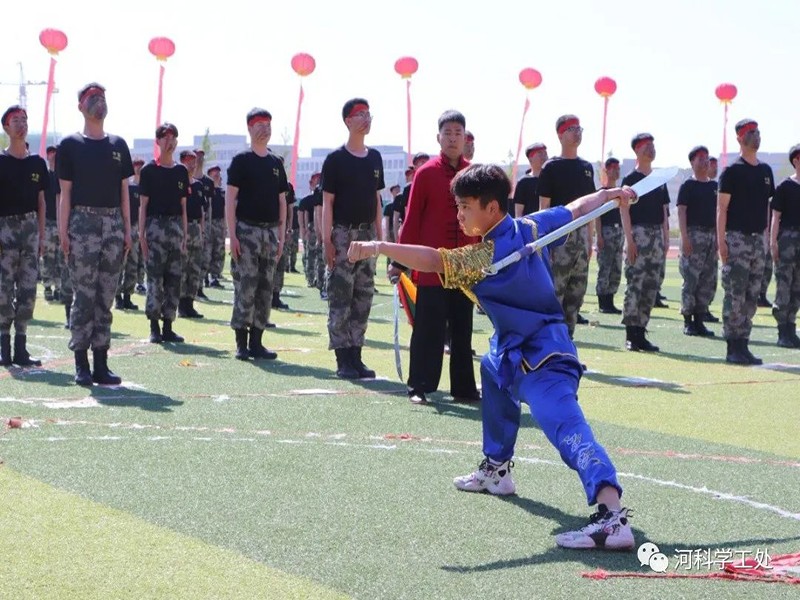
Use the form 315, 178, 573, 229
389, 110, 480, 404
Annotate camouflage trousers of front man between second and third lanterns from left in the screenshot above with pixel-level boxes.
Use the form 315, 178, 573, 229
231, 221, 278, 329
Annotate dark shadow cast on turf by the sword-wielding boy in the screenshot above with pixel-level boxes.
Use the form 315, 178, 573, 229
440, 496, 800, 574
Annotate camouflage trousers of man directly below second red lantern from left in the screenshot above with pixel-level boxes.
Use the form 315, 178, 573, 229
144, 217, 183, 321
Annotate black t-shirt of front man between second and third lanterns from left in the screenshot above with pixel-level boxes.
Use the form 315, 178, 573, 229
228, 150, 289, 223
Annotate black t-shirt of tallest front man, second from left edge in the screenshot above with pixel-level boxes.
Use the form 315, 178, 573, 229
56, 133, 133, 208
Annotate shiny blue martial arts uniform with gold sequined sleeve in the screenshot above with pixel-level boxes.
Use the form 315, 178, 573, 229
439, 207, 622, 505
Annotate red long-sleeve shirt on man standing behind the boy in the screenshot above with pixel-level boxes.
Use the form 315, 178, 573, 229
398, 154, 480, 286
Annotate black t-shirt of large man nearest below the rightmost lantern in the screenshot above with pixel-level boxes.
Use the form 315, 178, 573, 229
719, 156, 775, 233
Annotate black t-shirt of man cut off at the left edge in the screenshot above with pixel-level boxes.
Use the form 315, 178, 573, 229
0, 152, 50, 217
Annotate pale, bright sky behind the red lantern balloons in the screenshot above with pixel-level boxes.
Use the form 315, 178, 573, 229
0, 0, 800, 166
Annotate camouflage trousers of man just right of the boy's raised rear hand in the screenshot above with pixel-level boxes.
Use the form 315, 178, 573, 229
622, 225, 664, 327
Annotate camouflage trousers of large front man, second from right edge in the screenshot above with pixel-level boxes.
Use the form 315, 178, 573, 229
722, 231, 764, 340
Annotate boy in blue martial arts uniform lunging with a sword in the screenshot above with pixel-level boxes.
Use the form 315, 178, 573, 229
348, 164, 648, 550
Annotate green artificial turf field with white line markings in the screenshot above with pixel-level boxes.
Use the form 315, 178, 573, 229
0, 261, 800, 599
